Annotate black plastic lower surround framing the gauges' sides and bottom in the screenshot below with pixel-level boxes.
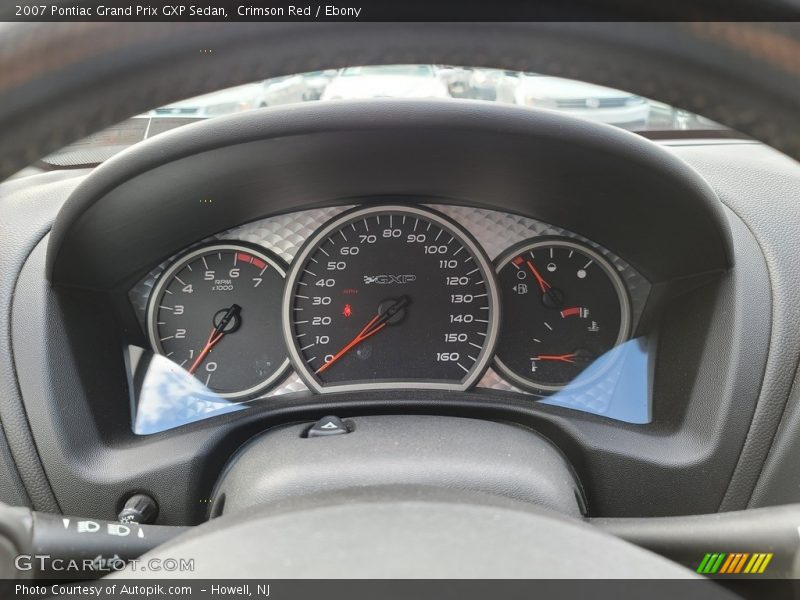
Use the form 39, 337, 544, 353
7, 200, 770, 524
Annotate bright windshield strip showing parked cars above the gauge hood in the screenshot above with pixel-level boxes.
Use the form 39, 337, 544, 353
26, 65, 724, 176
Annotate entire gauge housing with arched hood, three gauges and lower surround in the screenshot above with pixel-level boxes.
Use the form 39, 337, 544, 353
6, 100, 788, 524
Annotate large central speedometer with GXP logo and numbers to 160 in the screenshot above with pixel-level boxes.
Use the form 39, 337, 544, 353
284, 206, 499, 392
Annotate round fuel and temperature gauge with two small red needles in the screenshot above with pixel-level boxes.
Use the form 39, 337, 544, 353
495, 238, 630, 392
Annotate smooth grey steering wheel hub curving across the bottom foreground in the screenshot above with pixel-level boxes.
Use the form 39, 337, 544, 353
110, 485, 731, 580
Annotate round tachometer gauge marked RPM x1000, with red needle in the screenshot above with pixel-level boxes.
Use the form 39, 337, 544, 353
147, 243, 289, 399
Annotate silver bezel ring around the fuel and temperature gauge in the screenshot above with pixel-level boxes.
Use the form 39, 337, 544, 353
492, 235, 631, 395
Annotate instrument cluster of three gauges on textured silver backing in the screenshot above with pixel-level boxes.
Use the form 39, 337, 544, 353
129, 203, 650, 401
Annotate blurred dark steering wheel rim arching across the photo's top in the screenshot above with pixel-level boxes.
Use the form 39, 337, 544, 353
0, 22, 800, 179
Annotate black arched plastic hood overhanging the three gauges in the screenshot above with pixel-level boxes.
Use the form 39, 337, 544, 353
48, 100, 732, 290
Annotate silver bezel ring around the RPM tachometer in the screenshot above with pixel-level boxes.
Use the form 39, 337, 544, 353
145, 240, 291, 401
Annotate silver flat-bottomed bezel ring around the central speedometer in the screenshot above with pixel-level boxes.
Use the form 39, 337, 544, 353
282, 204, 501, 394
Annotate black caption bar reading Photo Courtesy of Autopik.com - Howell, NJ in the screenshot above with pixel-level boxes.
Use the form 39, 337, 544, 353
0, 578, 798, 600
